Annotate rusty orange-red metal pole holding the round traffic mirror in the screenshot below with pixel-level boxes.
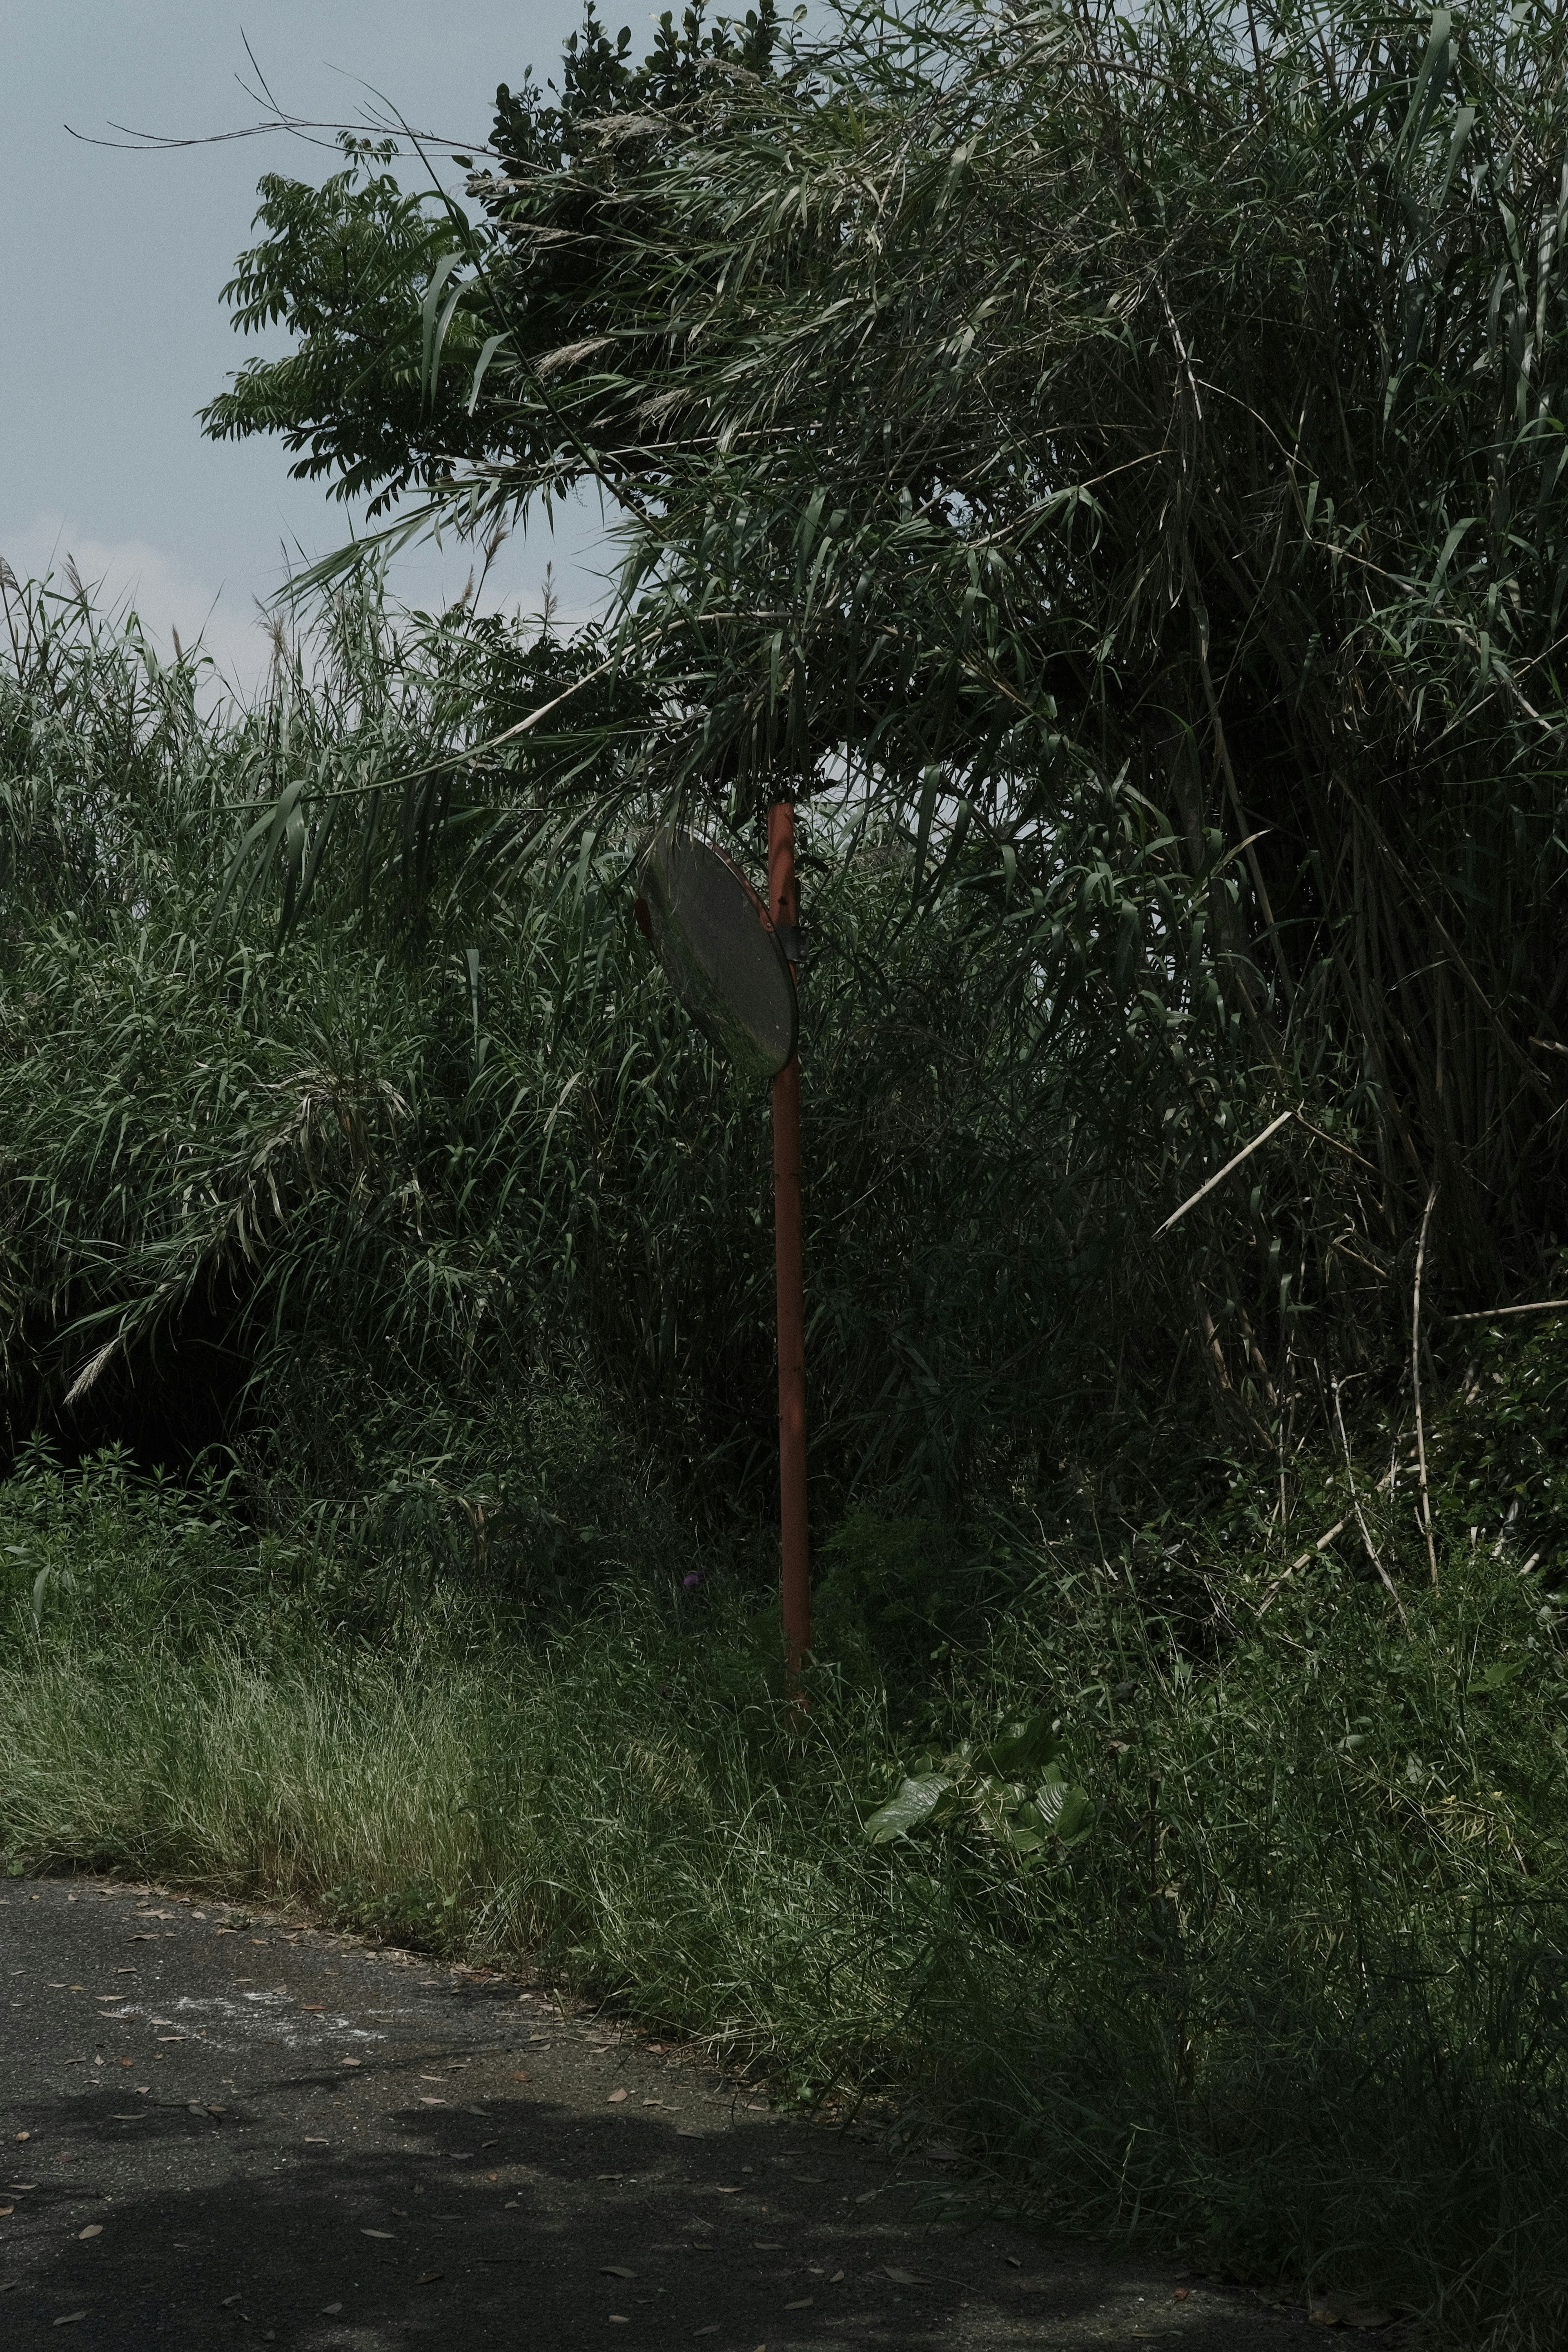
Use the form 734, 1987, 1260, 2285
769, 800, 811, 1684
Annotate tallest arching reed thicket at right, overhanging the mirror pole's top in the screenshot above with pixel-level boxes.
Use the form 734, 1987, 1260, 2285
200, 0, 1568, 1435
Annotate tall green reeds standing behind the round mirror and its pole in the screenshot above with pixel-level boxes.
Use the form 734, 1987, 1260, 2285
0, 559, 1133, 1515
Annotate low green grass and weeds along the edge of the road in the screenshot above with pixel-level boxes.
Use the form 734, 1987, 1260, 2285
0, 1456, 1568, 2347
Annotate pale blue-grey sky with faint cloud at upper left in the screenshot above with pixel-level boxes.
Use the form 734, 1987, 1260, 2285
0, 0, 611, 684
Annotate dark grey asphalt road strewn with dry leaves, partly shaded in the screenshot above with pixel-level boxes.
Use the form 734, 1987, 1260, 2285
0, 1879, 1305, 2352
